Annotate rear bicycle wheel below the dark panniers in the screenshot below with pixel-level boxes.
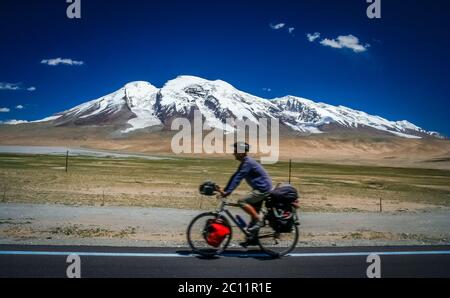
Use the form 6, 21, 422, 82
258, 215, 299, 257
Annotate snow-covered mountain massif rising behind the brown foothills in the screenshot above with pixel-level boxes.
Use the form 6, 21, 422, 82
25, 76, 441, 138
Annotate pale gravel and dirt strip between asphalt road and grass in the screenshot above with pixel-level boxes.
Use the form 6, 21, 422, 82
0, 204, 450, 247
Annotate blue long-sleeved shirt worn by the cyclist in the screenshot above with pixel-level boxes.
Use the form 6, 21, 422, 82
224, 156, 272, 195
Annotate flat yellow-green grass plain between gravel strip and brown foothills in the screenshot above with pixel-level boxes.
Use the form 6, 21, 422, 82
0, 154, 450, 212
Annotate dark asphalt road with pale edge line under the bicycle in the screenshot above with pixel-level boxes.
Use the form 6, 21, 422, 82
0, 245, 450, 278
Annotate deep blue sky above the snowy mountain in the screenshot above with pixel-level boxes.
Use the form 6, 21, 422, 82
0, 0, 450, 135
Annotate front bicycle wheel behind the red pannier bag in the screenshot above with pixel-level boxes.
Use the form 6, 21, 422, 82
187, 212, 232, 257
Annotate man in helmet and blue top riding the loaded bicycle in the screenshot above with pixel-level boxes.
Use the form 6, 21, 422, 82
218, 142, 272, 233
